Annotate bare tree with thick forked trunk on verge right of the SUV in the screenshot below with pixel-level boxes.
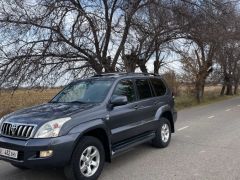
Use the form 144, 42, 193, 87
174, 1, 236, 103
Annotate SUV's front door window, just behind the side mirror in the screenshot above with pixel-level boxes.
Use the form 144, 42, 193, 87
113, 80, 136, 102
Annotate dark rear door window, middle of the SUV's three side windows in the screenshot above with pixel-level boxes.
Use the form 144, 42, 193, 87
136, 79, 152, 99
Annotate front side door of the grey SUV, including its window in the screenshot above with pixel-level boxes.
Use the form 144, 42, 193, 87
108, 79, 141, 144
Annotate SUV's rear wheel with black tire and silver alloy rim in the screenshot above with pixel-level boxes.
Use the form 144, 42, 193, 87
152, 118, 171, 148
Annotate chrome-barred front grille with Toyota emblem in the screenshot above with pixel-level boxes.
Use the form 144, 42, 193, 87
1, 123, 35, 139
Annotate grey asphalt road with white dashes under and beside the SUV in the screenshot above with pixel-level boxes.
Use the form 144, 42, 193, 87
0, 98, 240, 180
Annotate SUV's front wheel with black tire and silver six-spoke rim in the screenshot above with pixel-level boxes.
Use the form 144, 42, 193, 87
64, 136, 105, 180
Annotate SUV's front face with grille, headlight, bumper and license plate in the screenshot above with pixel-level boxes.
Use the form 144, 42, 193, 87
0, 114, 78, 168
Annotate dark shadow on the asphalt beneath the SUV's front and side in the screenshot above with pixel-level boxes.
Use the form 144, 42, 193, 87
0, 143, 172, 180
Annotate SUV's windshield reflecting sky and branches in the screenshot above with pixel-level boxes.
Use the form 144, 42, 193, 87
51, 80, 113, 103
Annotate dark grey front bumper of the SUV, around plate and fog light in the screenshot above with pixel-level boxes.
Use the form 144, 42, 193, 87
0, 134, 78, 168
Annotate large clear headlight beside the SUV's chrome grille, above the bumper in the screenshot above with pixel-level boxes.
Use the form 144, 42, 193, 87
34, 117, 71, 138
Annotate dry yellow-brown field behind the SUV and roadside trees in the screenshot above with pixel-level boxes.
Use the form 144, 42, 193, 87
0, 86, 236, 117
